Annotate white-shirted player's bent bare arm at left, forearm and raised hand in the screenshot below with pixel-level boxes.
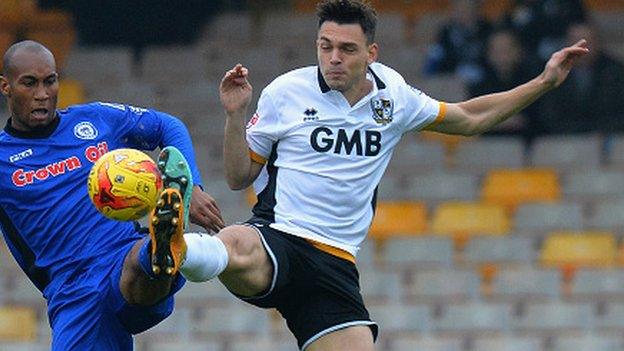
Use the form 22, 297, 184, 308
219, 64, 263, 190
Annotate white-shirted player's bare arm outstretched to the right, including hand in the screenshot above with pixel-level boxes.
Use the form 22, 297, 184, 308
425, 40, 588, 135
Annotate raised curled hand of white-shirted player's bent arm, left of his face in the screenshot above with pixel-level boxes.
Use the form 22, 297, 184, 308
219, 63, 253, 115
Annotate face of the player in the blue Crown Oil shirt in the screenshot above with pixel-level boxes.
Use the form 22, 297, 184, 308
0, 51, 58, 131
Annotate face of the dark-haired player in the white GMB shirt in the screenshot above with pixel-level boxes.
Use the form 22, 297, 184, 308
316, 21, 377, 96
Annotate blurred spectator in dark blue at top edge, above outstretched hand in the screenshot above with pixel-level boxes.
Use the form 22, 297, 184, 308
505, 0, 586, 61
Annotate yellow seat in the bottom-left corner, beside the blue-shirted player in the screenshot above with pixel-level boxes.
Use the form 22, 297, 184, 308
0, 306, 37, 341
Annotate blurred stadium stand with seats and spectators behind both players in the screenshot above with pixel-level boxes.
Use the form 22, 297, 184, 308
0, 0, 624, 351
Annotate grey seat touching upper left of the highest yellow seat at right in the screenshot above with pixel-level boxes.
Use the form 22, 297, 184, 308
453, 137, 524, 172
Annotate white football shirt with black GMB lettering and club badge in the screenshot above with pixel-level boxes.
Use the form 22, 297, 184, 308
247, 63, 445, 256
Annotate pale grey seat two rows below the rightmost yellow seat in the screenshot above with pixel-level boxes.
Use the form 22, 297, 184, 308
512, 301, 594, 335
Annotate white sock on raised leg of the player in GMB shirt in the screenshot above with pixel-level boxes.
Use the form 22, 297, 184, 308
180, 233, 229, 282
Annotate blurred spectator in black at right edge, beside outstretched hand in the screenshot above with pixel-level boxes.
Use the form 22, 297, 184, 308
539, 23, 624, 133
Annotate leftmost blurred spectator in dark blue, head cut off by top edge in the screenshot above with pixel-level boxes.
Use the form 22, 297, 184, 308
424, 0, 490, 82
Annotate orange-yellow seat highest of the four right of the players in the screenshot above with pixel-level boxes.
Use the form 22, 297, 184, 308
481, 168, 561, 213
